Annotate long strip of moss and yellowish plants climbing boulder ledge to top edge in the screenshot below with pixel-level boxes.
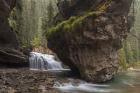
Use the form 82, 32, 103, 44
46, 0, 112, 39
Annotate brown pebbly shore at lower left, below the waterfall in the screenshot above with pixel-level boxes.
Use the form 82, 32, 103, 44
0, 68, 59, 93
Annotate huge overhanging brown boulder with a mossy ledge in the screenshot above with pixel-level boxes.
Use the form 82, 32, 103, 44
47, 0, 132, 82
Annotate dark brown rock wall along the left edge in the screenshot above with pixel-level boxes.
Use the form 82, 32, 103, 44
0, 0, 26, 64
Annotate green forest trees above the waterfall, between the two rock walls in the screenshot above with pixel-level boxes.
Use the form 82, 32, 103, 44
13, 0, 57, 47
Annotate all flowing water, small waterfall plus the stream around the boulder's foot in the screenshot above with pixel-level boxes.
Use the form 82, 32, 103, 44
30, 52, 140, 93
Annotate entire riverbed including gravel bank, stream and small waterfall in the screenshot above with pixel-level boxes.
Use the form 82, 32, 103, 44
0, 52, 140, 93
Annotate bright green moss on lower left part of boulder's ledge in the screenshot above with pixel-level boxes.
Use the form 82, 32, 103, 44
46, 12, 101, 39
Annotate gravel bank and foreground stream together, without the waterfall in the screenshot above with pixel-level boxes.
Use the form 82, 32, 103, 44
0, 68, 140, 93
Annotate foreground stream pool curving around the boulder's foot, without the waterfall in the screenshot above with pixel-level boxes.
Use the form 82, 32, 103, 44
53, 70, 140, 93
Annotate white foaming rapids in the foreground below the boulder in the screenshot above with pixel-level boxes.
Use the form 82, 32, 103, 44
53, 82, 117, 93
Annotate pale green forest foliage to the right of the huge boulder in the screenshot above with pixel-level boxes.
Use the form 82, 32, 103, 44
119, 0, 140, 65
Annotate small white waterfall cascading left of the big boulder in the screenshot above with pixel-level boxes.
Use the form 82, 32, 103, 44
29, 52, 68, 71
